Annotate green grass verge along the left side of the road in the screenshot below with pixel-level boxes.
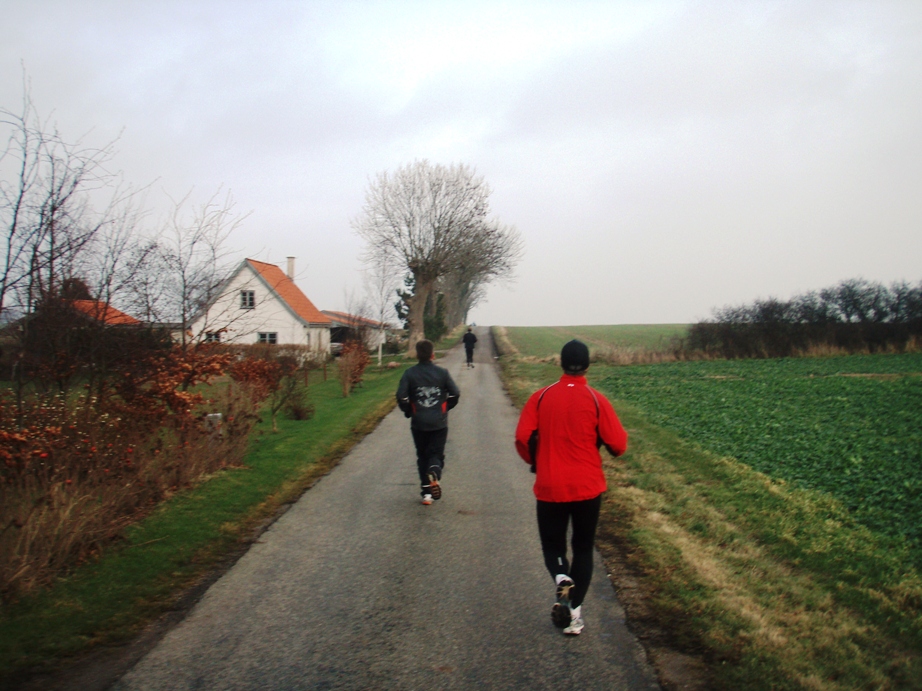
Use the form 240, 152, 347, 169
0, 366, 403, 688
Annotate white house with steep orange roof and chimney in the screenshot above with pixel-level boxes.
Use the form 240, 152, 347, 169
190, 257, 330, 353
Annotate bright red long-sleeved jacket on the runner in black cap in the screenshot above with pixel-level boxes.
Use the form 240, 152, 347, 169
515, 374, 627, 502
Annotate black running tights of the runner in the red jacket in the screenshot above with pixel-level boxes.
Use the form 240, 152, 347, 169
538, 494, 602, 607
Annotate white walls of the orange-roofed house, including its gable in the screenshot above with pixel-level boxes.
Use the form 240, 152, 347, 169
192, 265, 330, 352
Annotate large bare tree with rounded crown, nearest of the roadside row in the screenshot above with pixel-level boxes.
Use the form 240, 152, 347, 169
353, 160, 516, 352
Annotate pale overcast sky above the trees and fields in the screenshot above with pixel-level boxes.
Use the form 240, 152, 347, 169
0, 0, 922, 325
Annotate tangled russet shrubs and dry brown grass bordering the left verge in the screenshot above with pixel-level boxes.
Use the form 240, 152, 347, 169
0, 376, 256, 599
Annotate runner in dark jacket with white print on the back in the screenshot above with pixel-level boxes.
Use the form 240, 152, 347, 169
397, 340, 461, 506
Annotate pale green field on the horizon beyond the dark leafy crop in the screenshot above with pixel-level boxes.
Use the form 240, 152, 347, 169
506, 324, 688, 357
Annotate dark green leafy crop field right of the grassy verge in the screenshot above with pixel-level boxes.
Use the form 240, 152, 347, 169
597, 354, 922, 549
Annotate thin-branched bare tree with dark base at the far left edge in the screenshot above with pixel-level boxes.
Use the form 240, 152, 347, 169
0, 79, 167, 402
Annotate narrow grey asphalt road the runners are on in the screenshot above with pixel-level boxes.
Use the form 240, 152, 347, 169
115, 329, 658, 691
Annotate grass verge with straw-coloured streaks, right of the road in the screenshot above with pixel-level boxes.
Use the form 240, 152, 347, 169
497, 330, 922, 690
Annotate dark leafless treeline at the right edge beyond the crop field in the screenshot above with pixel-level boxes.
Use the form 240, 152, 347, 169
682, 279, 922, 358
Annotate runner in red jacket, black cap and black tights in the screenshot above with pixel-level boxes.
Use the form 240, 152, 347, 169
515, 340, 627, 635
